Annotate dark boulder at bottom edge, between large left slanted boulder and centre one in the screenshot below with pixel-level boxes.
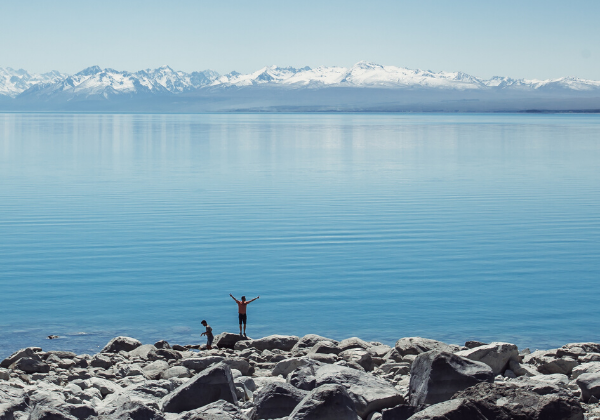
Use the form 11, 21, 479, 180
253, 382, 307, 419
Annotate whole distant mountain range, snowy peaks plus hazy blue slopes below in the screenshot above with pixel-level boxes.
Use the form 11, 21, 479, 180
0, 61, 600, 112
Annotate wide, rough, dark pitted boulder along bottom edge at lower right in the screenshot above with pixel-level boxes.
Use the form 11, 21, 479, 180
452, 383, 583, 420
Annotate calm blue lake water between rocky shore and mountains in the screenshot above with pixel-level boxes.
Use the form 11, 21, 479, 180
0, 114, 600, 356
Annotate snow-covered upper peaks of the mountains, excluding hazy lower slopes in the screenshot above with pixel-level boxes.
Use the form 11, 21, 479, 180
0, 61, 600, 100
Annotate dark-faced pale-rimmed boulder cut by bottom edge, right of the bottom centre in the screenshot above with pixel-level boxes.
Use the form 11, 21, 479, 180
288, 384, 360, 420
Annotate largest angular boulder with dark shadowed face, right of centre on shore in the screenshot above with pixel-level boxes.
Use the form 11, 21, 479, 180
409, 350, 494, 406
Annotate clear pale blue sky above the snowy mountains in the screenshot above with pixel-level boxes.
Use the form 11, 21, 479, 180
0, 0, 600, 80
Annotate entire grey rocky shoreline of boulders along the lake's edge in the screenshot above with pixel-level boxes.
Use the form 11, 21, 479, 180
0, 333, 600, 420
